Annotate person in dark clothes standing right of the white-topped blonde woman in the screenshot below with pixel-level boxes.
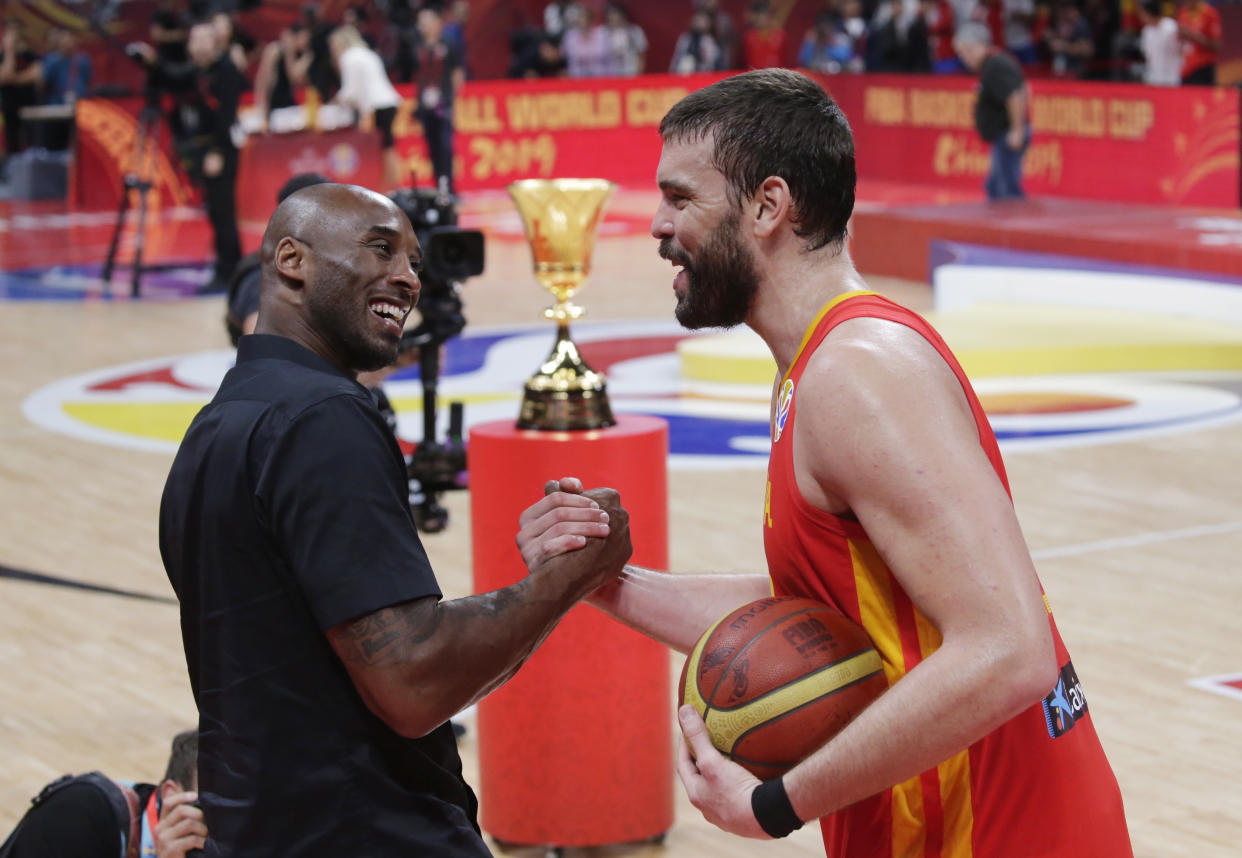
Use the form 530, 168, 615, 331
414, 4, 466, 194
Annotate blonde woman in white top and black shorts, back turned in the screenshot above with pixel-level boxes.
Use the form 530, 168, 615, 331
328, 26, 405, 190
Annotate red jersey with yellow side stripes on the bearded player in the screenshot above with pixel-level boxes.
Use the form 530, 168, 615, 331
764, 292, 1133, 858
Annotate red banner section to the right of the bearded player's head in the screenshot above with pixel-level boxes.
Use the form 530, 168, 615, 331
822, 75, 1240, 207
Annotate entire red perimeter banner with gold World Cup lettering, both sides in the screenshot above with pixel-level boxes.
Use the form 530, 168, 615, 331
76, 75, 1240, 219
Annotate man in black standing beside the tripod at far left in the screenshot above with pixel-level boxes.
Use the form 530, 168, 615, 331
178, 22, 247, 293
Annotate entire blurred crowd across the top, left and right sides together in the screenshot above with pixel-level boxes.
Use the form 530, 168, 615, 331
0, 0, 1221, 175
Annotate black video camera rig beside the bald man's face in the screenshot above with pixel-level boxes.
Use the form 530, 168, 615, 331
389, 187, 483, 533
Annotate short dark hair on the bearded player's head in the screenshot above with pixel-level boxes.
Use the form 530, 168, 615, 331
660, 68, 857, 250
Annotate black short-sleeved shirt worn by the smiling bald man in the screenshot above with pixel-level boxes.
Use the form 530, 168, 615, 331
160, 334, 488, 858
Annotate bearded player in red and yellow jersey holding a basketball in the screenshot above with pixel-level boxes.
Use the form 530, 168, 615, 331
551, 70, 1131, 858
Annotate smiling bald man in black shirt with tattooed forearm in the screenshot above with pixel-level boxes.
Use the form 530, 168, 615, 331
160, 184, 630, 858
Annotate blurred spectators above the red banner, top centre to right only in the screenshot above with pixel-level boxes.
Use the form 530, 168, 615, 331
509, 0, 1221, 86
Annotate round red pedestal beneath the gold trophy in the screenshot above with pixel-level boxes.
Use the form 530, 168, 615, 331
469, 415, 674, 846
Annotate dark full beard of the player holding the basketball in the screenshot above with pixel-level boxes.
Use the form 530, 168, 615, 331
661, 210, 759, 330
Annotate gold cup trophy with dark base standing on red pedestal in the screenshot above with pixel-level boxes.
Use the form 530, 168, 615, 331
508, 179, 616, 430
